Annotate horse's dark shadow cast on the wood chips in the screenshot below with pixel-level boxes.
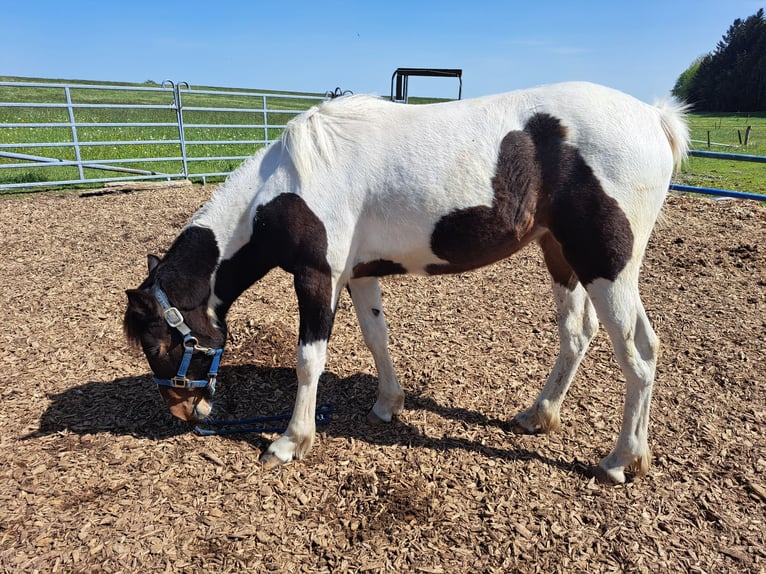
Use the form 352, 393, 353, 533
30, 365, 594, 478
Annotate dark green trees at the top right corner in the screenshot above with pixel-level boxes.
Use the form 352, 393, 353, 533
672, 8, 766, 112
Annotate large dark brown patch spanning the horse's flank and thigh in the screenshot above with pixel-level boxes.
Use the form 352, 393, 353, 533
426, 113, 633, 288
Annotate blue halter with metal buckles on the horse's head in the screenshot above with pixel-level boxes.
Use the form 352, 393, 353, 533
152, 285, 223, 395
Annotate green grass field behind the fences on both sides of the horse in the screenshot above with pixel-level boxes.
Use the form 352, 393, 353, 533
0, 76, 766, 200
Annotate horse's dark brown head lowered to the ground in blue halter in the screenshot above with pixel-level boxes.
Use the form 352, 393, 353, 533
123, 255, 226, 422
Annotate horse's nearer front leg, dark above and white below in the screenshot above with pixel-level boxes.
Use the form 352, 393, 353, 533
260, 269, 335, 469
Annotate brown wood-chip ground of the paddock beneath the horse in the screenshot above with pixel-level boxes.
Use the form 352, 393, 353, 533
0, 187, 766, 573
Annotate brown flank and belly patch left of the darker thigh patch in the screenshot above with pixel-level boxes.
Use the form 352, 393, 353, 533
426, 131, 541, 275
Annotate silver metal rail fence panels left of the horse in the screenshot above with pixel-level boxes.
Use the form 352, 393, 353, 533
0, 81, 326, 191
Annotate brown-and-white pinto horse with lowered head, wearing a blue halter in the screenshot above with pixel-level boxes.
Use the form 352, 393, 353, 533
124, 83, 689, 483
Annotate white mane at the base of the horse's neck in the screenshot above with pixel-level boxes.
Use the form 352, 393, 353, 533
281, 94, 390, 185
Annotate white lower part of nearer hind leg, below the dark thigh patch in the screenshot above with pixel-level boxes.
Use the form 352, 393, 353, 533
588, 274, 659, 484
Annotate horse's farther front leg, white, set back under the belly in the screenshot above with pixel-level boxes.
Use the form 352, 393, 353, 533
348, 277, 404, 424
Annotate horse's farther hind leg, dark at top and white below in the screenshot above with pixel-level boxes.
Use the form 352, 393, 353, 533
513, 235, 598, 434
